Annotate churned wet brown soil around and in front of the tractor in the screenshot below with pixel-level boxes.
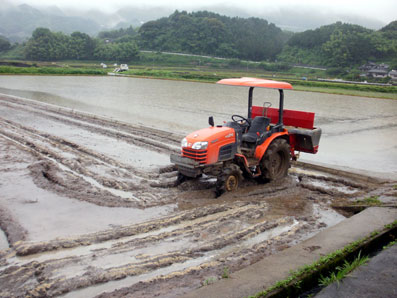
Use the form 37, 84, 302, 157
0, 95, 396, 297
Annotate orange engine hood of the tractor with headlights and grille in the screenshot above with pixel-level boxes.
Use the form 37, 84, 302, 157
181, 126, 237, 164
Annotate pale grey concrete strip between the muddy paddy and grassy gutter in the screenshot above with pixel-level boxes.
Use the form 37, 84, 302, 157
183, 207, 397, 298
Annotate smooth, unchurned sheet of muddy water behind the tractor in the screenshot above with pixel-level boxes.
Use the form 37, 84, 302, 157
0, 76, 397, 176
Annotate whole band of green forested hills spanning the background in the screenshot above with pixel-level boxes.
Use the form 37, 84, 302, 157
0, 11, 397, 69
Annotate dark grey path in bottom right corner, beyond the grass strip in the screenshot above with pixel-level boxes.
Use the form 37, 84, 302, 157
315, 245, 397, 298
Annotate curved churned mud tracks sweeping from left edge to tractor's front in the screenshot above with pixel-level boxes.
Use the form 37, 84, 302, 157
0, 118, 181, 208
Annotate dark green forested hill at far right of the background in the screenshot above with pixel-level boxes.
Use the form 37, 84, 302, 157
278, 21, 397, 67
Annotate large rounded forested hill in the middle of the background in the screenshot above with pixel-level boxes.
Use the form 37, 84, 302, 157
139, 11, 288, 61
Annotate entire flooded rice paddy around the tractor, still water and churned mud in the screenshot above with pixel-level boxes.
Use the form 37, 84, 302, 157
0, 77, 397, 297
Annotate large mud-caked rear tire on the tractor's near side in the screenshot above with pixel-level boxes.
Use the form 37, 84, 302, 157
261, 139, 291, 182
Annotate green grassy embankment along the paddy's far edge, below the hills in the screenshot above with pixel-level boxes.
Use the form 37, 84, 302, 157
0, 53, 397, 99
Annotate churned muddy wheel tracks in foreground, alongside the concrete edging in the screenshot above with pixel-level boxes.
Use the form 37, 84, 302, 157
1, 176, 346, 297
